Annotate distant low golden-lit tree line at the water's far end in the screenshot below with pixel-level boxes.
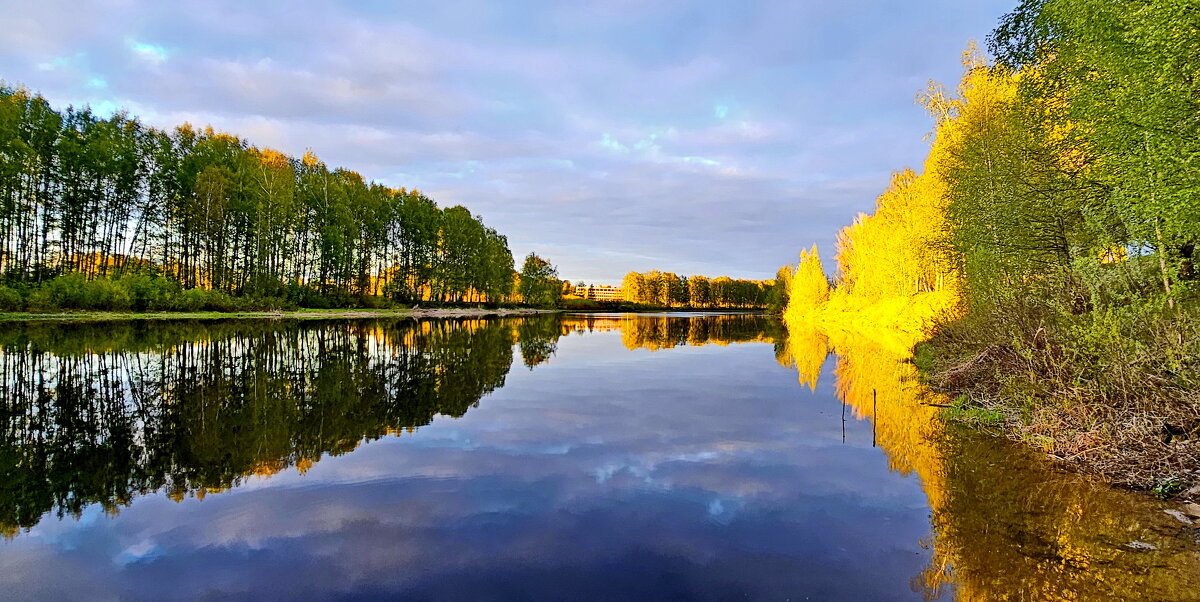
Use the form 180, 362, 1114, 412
620, 270, 775, 308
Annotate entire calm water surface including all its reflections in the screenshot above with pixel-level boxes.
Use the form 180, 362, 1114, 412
0, 314, 1200, 600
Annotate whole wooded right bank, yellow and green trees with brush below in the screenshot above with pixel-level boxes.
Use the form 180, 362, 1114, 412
780, 0, 1200, 496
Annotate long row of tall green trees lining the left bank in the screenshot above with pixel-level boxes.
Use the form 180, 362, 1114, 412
0, 88, 540, 311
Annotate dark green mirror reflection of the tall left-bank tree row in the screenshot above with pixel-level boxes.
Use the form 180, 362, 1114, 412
0, 319, 520, 536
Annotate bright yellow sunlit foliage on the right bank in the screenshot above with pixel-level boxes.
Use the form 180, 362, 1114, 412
785, 51, 1032, 335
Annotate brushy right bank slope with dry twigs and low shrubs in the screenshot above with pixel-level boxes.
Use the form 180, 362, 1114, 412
914, 295, 1200, 501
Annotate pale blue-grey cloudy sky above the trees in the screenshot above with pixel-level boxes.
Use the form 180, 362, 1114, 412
0, 0, 1015, 284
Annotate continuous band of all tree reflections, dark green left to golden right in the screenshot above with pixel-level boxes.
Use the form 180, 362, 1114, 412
0, 314, 1200, 600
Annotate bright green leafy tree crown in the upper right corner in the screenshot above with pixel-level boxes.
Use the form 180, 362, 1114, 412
992, 0, 1200, 297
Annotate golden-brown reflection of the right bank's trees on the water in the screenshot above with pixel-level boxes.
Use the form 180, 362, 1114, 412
780, 324, 1200, 600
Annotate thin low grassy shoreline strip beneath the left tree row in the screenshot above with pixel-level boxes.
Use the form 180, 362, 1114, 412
0, 307, 560, 323
